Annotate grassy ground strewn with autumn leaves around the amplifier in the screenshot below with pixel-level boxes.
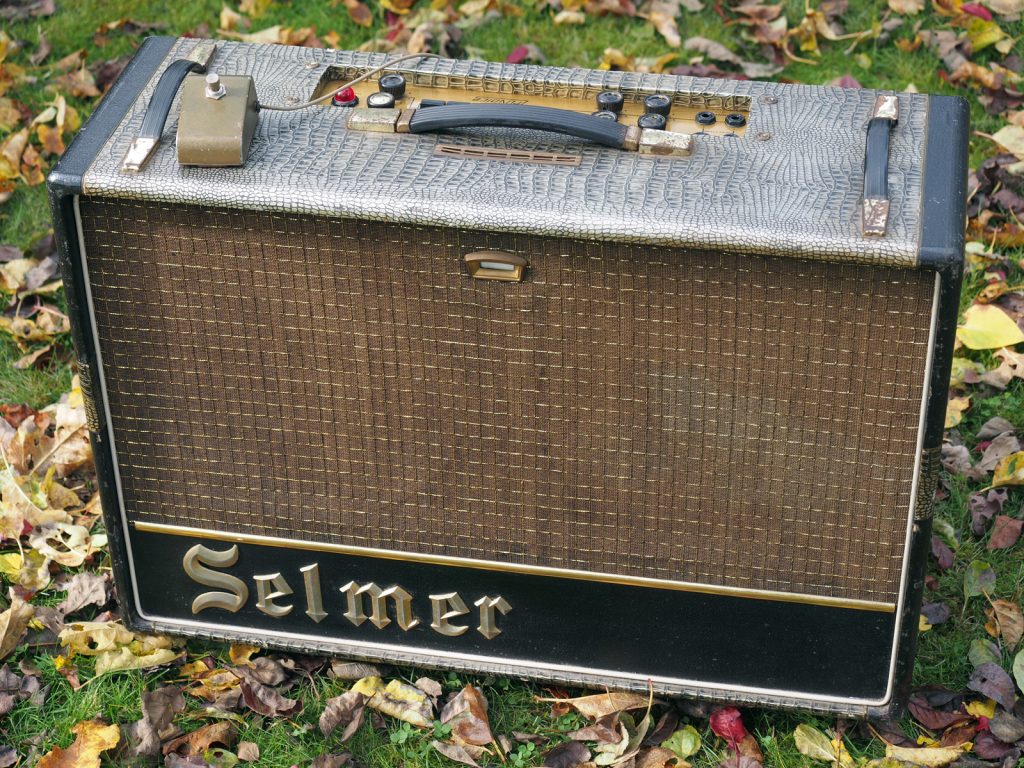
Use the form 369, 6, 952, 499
0, 0, 1024, 768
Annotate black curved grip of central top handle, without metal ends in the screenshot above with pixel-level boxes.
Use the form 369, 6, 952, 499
409, 104, 628, 150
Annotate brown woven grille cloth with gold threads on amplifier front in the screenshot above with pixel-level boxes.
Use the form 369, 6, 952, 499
81, 199, 933, 601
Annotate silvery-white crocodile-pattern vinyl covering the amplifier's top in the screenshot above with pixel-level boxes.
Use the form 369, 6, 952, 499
84, 39, 928, 267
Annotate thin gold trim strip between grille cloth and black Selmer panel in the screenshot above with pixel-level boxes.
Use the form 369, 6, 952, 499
132, 521, 896, 613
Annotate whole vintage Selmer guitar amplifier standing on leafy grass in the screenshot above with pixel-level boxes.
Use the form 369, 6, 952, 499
49, 38, 968, 716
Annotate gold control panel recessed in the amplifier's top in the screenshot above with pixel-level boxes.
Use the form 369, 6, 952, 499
311, 67, 752, 136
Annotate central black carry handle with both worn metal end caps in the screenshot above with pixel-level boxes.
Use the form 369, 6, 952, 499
347, 103, 692, 157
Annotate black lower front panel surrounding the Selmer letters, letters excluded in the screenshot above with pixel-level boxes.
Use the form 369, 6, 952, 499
131, 530, 895, 699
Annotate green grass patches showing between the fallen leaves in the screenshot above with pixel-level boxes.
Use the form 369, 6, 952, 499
0, 0, 1024, 768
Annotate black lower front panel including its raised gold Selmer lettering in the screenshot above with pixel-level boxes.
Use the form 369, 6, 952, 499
130, 524, 896, 706
